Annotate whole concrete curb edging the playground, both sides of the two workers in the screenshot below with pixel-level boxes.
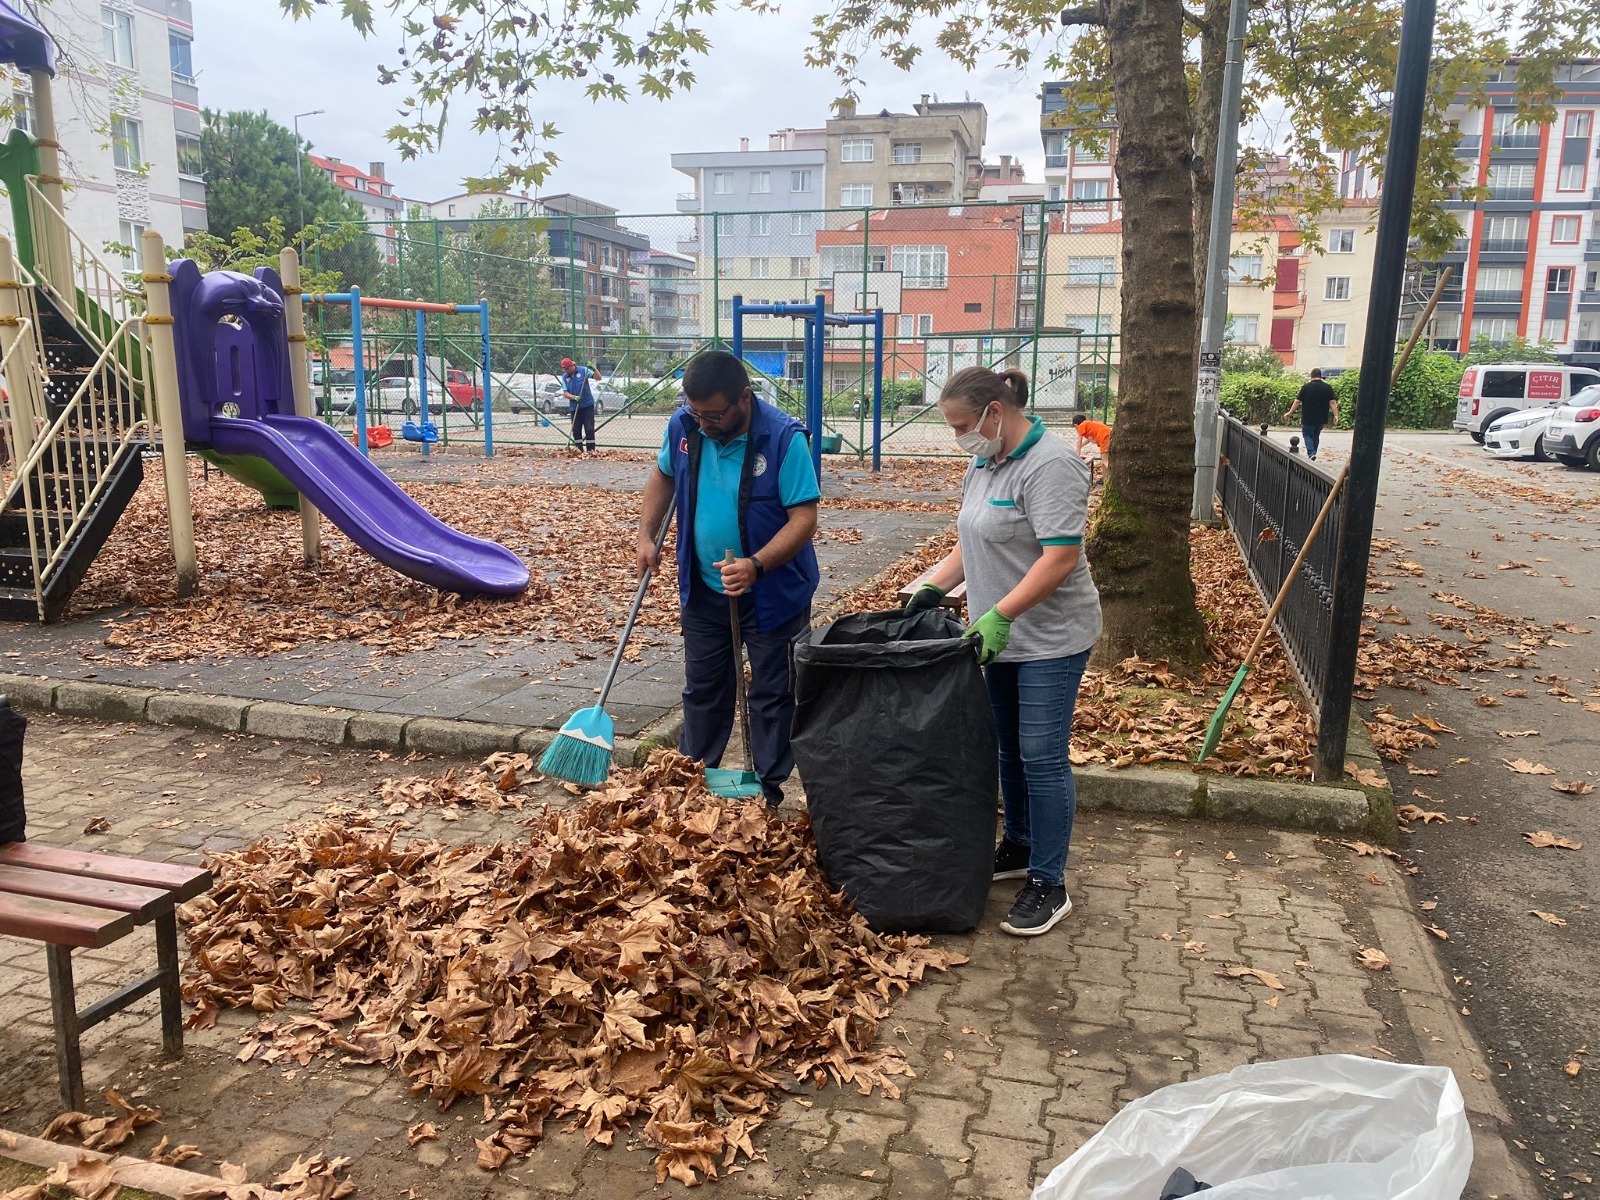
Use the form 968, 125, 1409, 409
0, 675, 1395, 842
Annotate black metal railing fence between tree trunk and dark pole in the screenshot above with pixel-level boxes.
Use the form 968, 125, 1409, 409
1216, 418, 1339, 712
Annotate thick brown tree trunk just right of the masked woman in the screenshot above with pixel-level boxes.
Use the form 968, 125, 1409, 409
1088, 0, 1205, 664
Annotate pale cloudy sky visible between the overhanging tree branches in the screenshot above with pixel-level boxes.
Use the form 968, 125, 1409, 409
194, 0, 1043, 213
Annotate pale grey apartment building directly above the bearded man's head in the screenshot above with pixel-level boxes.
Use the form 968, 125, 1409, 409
672, 128, 827, 350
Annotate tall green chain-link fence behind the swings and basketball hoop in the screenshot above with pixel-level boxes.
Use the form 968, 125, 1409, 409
307, 197, 1120, 456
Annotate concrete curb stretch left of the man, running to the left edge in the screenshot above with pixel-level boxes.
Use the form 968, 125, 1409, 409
0, 675, 683, 766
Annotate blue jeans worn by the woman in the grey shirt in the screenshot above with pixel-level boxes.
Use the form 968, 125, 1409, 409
984, 650, 1090, 885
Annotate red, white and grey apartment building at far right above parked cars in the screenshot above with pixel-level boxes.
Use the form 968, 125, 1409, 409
1401, 59, 1600, 365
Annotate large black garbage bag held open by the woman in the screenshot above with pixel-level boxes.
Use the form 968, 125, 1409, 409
794, 610, 1000, 933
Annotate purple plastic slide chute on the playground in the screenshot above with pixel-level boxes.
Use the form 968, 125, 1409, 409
211, 414, 528, 595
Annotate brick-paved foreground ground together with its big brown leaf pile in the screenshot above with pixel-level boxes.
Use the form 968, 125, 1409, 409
0, 717, 1523, 1200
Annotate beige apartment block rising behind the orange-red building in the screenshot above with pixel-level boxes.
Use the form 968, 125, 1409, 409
827, 96, 989, 208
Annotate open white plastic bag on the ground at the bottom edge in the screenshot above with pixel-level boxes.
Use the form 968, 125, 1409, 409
1034, 1054, 1472, 1200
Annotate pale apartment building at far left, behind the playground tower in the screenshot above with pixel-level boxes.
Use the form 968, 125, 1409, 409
0, 0, 206, 270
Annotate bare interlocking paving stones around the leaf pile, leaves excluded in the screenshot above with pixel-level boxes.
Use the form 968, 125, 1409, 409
0, 717, 1533, 1200
